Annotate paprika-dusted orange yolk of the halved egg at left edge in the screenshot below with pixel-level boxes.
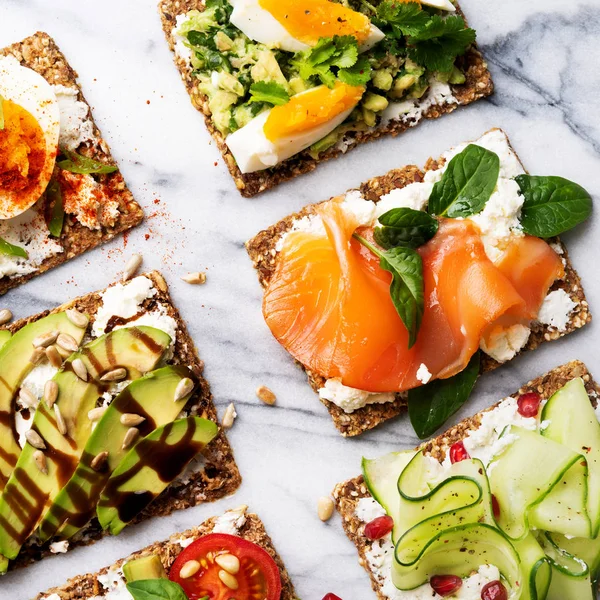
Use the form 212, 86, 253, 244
0, 100, 46, 204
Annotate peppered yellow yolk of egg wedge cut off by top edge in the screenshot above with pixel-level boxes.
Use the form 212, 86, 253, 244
259, 0, 371, 45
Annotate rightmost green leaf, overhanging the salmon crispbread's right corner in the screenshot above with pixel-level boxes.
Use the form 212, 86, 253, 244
515, 175, 592, 238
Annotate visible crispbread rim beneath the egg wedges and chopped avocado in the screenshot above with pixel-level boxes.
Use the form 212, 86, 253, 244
158, 0, 494, 198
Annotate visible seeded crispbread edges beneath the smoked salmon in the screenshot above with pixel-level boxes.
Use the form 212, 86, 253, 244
246, 130, 592, 437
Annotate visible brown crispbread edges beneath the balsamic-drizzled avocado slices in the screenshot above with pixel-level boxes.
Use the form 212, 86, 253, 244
5, 271, 241, 570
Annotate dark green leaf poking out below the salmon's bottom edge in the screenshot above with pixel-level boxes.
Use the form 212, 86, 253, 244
408, 352, 480, 439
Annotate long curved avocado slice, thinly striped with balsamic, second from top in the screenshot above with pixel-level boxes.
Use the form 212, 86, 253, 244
0, 327, 171, 560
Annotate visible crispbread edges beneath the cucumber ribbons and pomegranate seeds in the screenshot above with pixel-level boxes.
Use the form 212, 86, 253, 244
333, 360, 600, 600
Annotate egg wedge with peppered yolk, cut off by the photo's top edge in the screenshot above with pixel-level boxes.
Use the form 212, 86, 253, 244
230, 0, 385, 52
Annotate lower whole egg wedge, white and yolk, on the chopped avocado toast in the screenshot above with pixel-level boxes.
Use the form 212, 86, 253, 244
225, 81, 365, 173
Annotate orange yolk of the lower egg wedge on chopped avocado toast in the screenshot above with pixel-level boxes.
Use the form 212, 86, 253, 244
263, 81, 365, 142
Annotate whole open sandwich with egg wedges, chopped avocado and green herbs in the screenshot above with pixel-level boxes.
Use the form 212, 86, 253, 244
159, 0, 493, 196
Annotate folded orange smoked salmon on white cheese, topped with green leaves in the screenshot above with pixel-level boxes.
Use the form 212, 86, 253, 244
263, 198, 562, 392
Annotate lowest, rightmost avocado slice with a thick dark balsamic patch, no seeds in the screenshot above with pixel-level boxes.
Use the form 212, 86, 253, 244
97, 417, 219, 535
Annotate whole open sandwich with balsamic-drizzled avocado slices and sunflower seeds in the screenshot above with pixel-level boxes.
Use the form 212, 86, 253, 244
0, 272, 240, 572
